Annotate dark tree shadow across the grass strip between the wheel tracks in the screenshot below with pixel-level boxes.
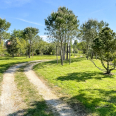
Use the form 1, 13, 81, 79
7, 101, 53, 116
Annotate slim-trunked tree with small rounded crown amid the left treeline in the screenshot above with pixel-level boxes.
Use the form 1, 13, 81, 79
23, 27, 39, 58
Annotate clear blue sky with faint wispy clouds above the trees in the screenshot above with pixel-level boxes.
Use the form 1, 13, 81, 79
0, 0, 116, 39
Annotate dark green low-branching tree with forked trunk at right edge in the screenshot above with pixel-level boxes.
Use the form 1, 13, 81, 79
92, 27, 116, 74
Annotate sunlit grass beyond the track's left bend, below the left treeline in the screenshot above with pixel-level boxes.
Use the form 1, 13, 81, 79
0, 55, 56, 95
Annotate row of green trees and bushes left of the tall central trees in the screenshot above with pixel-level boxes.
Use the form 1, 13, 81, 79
0, 19, 55, 58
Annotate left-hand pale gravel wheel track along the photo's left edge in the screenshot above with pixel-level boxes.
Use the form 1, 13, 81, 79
0, 63, 26, 116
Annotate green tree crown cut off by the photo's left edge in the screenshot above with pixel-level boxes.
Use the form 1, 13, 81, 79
0, 18, 11, 43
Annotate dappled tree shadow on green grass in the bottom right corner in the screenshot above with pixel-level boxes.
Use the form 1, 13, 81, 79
69, 89, 116, 116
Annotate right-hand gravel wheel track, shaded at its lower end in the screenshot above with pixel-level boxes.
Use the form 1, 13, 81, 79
24, 63, 77, 116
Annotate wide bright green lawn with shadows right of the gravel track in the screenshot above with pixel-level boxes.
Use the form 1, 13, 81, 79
34, 58, 116, 116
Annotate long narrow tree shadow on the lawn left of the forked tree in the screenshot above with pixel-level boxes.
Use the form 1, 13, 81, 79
57, 71, 113, 82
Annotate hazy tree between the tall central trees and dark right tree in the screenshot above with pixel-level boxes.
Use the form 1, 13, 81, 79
81, 19, 109, 59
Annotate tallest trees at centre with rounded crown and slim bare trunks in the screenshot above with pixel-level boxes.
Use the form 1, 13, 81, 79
45, 7, 79, 65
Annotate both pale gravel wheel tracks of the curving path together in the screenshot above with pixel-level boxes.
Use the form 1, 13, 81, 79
0, 60, 77, 116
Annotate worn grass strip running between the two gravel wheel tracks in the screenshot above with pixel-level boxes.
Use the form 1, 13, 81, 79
13, 67, 53, 116
